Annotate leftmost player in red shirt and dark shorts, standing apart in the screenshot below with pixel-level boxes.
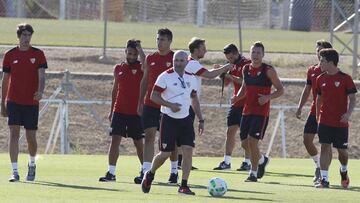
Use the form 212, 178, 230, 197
1, 23, 48, 182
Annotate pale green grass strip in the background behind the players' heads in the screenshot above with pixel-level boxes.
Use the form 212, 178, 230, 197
0, 18, 351, 53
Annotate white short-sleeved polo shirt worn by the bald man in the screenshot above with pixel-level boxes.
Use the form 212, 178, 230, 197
153, 68, 198, 119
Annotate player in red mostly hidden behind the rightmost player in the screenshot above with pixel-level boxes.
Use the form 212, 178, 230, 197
295, 40, 332, 183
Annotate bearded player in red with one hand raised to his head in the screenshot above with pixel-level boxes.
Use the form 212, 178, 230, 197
99, 39, 145, 182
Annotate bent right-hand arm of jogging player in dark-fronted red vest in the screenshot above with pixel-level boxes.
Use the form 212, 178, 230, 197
258, 68, 284, 105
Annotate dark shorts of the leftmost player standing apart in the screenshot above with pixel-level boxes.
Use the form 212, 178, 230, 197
6, 101, 39, 130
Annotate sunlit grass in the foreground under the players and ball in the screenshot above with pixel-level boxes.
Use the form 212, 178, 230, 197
0, 154, 360, 203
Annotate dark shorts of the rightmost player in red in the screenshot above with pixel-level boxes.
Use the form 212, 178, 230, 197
318, 124, 349, 149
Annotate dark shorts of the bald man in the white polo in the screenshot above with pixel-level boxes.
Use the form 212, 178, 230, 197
159, 114, 195, 152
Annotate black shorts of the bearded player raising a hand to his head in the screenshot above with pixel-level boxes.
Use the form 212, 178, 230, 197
110, 112, 144, 140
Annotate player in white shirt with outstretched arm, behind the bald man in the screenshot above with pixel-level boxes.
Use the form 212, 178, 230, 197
178, 37, 232, 169
